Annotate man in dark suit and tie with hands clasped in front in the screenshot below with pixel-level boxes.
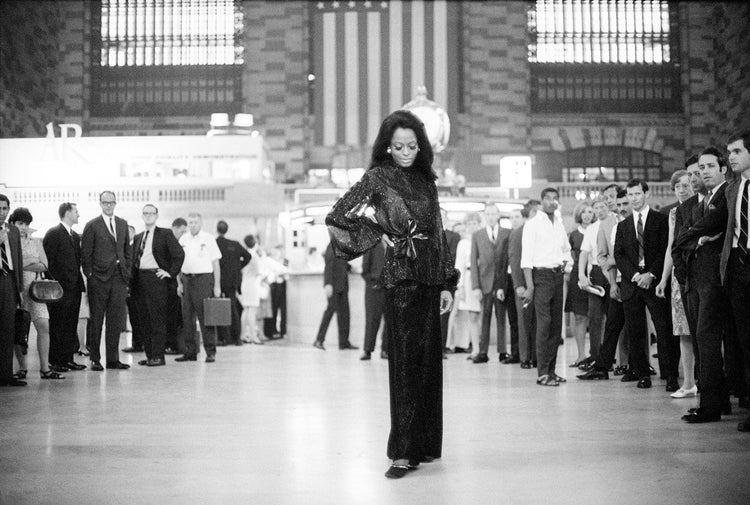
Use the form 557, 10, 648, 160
614, 179, 679, 391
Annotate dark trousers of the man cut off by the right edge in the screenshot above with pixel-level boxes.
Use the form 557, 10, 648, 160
728, 248, 750, 404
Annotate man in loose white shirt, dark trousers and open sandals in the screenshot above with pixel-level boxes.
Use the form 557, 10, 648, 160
521, 188, 573, 386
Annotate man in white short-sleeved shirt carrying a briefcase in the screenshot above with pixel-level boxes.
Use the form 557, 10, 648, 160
175, 212, 221, 363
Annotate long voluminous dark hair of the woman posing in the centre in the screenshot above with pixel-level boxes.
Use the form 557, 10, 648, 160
368, 110, 437, 181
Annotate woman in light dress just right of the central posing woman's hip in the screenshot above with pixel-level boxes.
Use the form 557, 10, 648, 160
446, 212, 482, 352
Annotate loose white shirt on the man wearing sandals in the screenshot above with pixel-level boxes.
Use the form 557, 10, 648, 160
521, 211, 573, 268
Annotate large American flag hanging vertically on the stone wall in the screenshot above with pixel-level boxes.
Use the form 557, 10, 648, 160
311, 0, 459, 146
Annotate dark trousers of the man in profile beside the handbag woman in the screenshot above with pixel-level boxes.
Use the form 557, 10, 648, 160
47, 290, 81, 365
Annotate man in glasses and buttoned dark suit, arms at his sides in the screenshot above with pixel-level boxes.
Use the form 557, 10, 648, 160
81, 191, 131, 371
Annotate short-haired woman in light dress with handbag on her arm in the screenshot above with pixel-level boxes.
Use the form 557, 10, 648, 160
8, 207, 65, 379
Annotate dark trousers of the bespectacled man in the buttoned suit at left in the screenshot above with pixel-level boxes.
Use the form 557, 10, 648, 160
88, 275, 128, 363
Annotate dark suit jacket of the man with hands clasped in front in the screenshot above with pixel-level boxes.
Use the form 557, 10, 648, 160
614, 209, 669, 300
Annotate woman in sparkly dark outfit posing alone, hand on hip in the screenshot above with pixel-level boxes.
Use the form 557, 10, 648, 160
326, 110, 458, 478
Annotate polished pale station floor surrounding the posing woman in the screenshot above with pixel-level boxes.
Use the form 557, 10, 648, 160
0, 327, 750, 505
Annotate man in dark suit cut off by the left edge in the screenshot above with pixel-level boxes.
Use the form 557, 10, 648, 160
0, 194, 26, 386
